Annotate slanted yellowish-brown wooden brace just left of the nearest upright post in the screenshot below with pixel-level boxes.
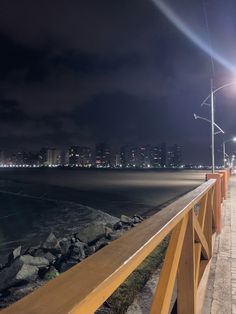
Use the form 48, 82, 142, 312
150, 215, 188, 314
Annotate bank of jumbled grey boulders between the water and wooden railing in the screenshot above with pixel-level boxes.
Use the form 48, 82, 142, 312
0, 215, 143, 308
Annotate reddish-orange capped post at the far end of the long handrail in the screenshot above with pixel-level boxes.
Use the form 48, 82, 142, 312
206, 173, 221, 233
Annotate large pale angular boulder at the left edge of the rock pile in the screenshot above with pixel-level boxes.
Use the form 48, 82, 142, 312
0, 258, 39, 291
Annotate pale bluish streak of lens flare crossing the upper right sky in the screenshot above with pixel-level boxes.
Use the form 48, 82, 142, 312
151, 0, 236, 74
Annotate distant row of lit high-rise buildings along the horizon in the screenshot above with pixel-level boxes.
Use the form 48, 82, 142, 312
0, 142, 184, 168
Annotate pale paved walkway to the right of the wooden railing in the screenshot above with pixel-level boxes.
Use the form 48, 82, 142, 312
204, 176, 236, 314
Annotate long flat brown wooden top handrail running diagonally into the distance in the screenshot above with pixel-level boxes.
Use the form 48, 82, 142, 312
1, 179, 216, 314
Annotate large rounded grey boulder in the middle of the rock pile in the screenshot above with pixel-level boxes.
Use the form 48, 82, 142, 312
76, 222, 107, 244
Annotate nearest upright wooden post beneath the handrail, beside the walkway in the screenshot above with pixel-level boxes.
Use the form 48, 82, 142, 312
177, 210, 196, 314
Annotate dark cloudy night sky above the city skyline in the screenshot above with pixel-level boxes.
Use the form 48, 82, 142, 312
0, 0, 236, 162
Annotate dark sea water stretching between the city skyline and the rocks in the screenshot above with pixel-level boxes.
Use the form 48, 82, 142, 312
0, 169, 205, 262
